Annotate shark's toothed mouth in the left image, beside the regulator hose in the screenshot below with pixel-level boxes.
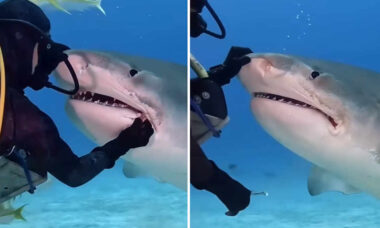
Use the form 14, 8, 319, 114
70, 91, 141, 113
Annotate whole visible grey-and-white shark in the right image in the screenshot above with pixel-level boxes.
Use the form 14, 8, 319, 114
239, 54, 380, 198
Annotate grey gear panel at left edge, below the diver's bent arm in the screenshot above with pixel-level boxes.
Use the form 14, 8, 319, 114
0, 156, 47, 204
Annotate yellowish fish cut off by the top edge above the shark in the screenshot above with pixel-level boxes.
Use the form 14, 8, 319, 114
29, 0, 106, 15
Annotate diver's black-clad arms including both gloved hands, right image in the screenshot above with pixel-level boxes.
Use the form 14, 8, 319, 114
190, 47, 252, 216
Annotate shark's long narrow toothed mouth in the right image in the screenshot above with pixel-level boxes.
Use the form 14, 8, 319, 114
253, 93, 338, 128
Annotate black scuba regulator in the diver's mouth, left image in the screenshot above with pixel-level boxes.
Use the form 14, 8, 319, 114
29, 38, 70, 90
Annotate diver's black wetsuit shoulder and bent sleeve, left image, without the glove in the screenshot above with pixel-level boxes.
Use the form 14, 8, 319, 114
0, 88, 114, 187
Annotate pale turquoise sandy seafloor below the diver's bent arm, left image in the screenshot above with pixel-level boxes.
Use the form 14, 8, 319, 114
5, 161, 187, 228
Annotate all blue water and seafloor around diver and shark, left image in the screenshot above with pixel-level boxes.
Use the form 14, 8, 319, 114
6, 0, 187, 228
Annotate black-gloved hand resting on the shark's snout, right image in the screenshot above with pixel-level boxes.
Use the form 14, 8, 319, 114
208, 47, 253, 86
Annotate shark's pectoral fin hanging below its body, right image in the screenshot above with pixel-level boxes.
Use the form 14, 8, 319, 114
307, 166, 360, 196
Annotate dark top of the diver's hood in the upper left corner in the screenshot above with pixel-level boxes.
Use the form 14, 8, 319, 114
0, 0, 50, 36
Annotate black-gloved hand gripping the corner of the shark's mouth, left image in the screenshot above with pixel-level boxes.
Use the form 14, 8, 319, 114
93, 119, 153, 168
